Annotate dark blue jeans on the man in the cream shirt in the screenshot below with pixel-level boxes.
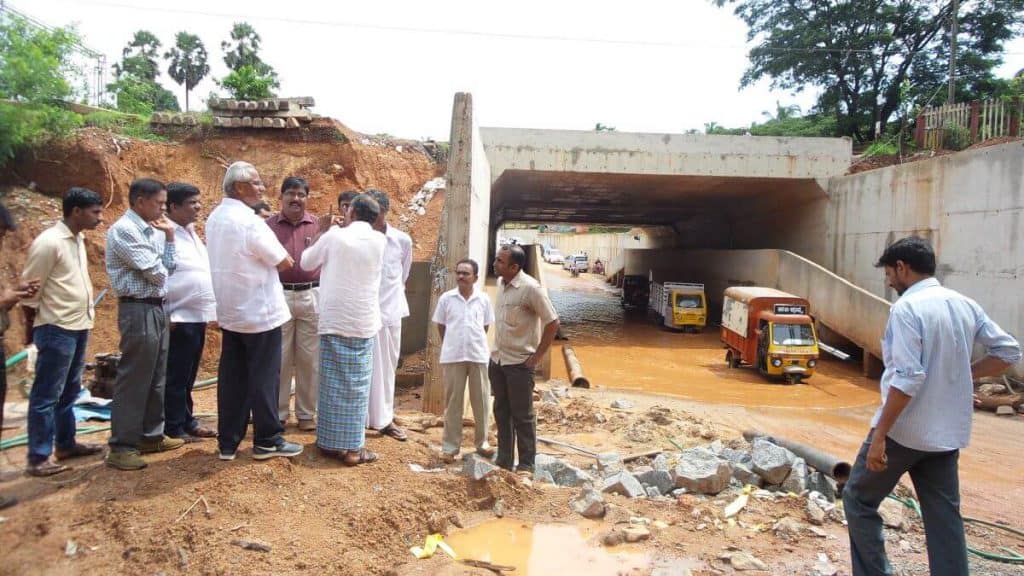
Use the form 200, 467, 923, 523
28, 324, 89, 464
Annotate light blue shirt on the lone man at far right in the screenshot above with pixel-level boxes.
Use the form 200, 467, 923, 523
871, 278, 1021, 452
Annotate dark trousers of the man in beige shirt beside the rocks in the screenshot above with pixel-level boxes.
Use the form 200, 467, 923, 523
487, 362, 537, 471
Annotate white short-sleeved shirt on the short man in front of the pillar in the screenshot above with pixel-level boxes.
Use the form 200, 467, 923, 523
434, 288, 495, 364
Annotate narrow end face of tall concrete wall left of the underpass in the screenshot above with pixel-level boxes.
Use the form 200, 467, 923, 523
423, 92, 473, 414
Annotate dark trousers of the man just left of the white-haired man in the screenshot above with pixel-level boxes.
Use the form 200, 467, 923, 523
164, 322, 206, 438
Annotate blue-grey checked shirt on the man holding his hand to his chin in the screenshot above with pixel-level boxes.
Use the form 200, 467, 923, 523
106, 208, 175, 298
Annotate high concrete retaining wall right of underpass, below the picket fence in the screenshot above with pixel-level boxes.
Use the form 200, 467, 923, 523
823, 141, 1024, 376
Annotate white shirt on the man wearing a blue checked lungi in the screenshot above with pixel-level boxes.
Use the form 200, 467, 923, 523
299, 221, 387, 338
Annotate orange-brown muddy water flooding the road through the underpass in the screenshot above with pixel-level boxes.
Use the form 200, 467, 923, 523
545, 268, 879, 409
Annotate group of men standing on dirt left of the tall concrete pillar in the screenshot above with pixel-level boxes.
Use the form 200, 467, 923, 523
0, 162, 423, 477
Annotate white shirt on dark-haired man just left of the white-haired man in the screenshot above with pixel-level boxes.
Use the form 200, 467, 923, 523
167, 223, 217, 322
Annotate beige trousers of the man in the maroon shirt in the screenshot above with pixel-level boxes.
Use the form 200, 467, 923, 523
278, 288, 319, 420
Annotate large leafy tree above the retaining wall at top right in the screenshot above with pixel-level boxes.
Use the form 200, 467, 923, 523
712, 0, 1024, 141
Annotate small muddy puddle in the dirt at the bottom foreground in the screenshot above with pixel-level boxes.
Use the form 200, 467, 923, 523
446, 519, 651, 576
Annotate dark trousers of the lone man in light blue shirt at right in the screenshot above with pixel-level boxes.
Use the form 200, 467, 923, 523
843, 434, 968, 576
